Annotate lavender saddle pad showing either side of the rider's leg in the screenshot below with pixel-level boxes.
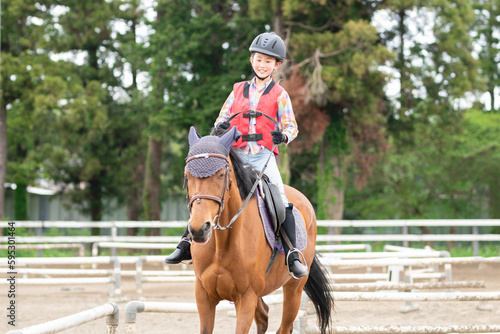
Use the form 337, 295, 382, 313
256, 187, 307, 254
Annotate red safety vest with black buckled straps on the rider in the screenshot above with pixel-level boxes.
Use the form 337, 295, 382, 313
229, 81, 284, 155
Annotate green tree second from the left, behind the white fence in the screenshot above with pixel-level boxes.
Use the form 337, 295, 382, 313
36, 1, 141, 227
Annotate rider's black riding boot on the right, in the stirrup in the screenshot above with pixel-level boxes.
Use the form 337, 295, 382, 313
281, 203, 308, 278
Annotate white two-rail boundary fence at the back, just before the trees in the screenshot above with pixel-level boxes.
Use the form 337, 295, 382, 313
0, 219, 500, 256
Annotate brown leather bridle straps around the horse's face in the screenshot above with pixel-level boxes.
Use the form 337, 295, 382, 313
186, 153, 231, 230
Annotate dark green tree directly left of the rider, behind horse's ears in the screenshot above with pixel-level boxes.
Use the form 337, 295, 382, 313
140, 0, 256, 226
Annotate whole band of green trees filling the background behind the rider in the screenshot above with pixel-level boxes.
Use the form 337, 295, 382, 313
0, 0, 500, 224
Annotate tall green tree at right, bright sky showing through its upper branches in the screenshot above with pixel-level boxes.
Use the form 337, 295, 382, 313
353, 1, 482, 233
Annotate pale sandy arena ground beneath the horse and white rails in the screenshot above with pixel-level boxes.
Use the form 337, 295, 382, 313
0, 265, 500, 334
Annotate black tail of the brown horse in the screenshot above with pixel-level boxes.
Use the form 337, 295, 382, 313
304, 253, 333, 334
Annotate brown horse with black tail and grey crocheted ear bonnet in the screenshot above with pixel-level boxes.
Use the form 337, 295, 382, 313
185, 127, 333, 334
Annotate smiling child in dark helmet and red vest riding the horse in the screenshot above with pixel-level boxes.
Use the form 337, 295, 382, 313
165, 33, 307, 278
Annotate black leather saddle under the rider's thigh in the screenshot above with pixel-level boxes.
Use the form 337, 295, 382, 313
259, 174, 286, 234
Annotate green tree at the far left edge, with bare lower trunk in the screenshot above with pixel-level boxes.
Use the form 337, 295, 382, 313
0, 0, 55, 220
